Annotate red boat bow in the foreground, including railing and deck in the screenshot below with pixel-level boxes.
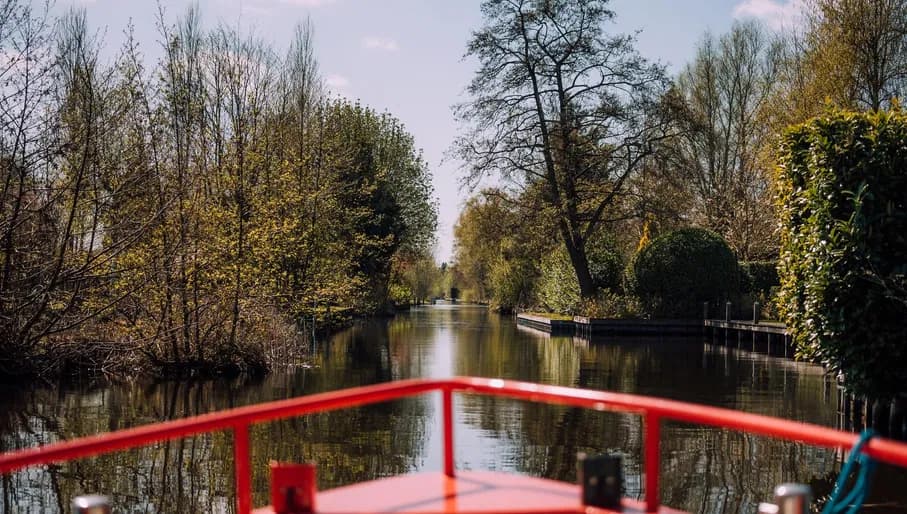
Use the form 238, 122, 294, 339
0, 377, 907, 514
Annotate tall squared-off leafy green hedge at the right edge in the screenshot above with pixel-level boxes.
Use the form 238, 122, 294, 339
777, 111, 907, 397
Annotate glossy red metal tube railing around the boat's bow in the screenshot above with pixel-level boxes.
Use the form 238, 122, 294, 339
0, 377, 907, 514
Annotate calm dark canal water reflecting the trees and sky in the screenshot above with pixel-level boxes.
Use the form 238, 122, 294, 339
0, 305, 907, 513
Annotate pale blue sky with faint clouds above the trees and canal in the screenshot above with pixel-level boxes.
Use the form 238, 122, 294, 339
51, 0, 803, 263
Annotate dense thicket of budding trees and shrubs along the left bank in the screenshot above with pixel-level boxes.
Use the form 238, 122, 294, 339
0, 4, 437, 381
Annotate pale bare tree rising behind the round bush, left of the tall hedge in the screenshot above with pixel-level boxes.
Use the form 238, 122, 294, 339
660, 22, 778, 259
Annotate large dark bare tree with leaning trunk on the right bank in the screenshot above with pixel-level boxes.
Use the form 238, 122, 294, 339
455, 0, 665, 297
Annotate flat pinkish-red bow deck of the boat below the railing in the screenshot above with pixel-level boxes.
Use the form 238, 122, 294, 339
254, 471, 683, 514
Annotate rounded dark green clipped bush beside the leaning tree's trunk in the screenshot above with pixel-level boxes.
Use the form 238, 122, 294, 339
628, 228, 738, 318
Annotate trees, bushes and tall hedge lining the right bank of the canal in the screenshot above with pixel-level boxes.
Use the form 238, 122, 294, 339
452, 0, 907, 397
